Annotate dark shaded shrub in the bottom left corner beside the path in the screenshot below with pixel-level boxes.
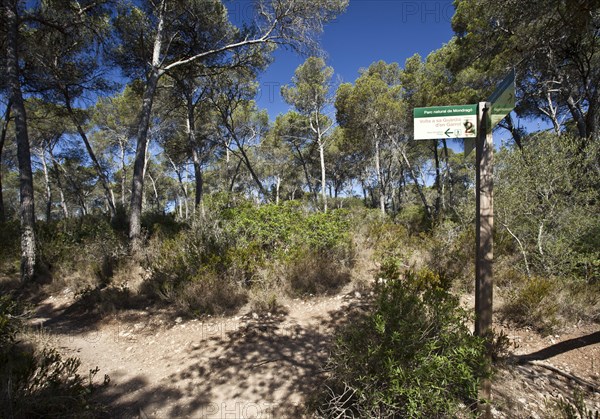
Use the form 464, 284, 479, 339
0, 295, 108, 419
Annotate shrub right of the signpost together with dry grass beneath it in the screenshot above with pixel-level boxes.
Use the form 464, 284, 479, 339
494, 134, 600, 330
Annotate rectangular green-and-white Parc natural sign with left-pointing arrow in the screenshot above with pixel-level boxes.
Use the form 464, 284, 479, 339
413, 105, 477, 140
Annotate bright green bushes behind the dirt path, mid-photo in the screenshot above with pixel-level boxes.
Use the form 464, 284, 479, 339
147, 202, 353, 314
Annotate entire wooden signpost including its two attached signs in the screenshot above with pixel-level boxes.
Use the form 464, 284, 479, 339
414, 71, 515, 416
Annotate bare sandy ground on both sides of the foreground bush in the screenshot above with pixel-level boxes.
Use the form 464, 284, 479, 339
24, 287, 600, 418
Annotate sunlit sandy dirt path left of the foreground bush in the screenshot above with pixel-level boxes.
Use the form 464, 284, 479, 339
28, 292, 360, 418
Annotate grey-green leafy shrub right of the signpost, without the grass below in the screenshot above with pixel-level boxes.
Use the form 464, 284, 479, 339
494, 134, 600, 282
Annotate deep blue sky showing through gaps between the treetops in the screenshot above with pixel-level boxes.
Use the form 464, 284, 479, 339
244, 0, 454, 119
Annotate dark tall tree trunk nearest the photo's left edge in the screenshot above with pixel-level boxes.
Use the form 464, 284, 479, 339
2, 0, 36, 282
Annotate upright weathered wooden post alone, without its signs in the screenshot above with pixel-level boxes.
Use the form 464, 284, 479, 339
475, 102, 494, 417
